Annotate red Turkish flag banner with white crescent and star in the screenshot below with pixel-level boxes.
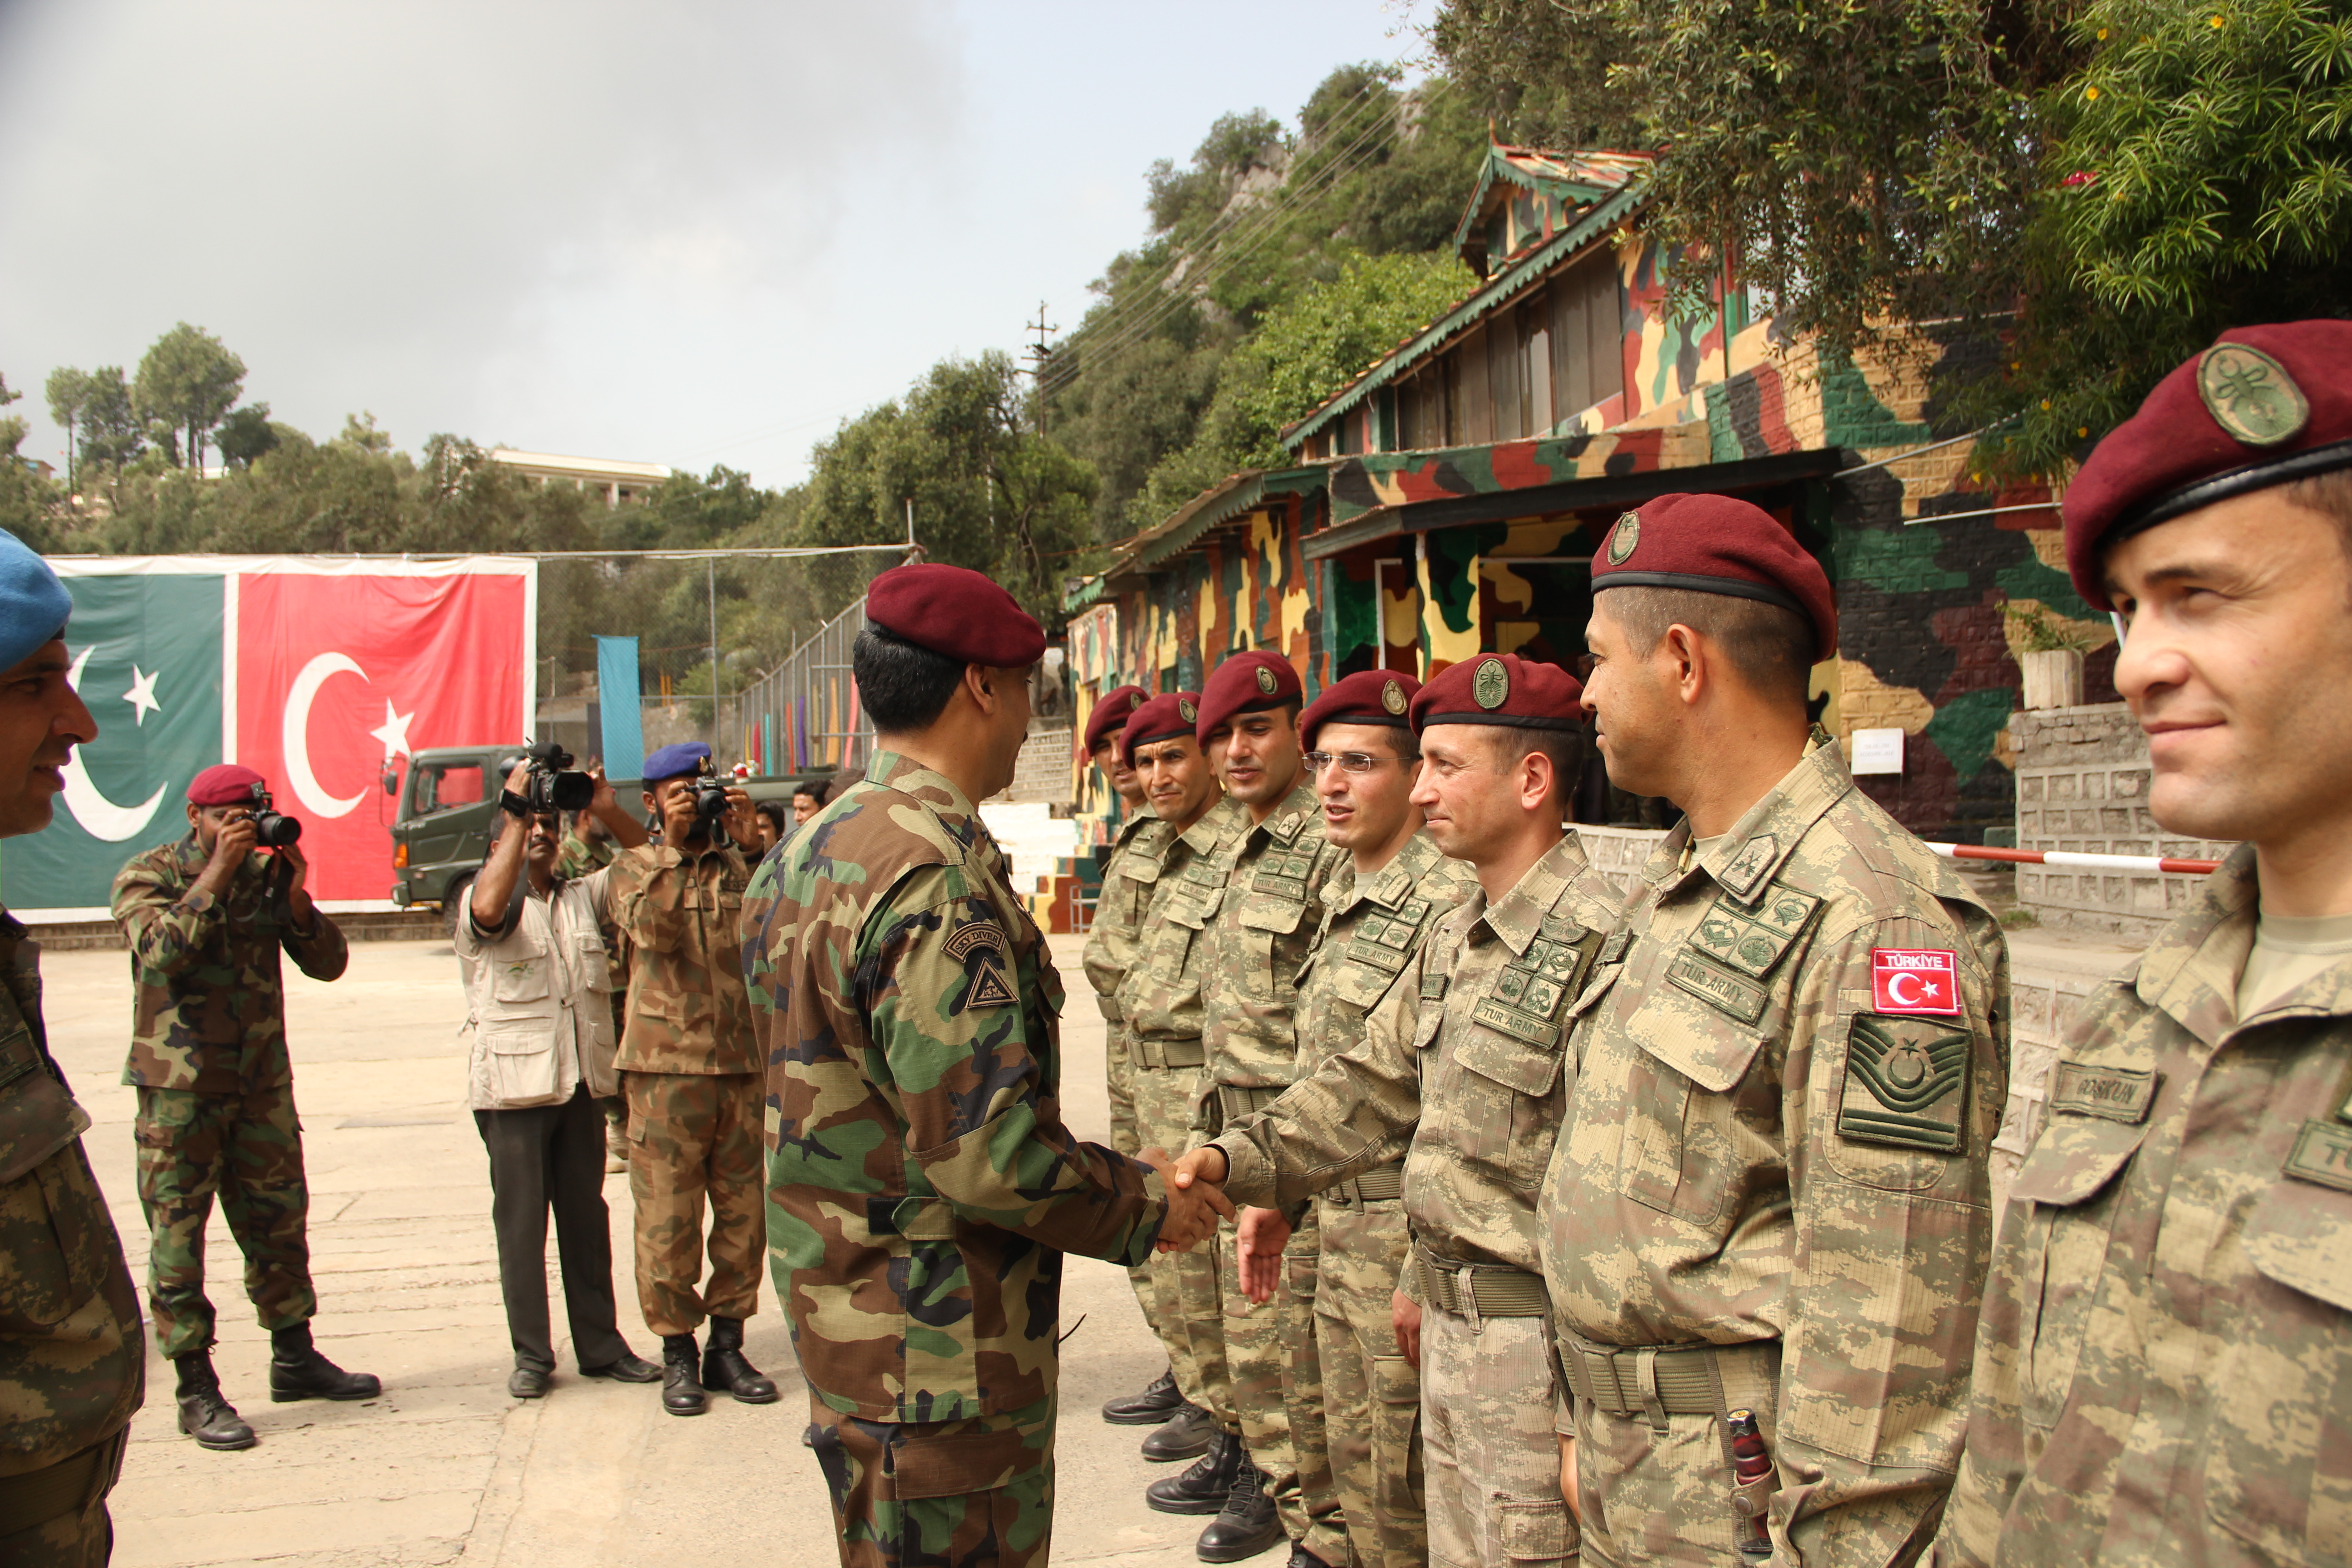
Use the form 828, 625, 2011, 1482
221, 571, 536, 900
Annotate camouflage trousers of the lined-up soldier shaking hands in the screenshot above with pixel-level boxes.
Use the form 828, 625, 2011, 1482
1421, 1305, 1576, 1568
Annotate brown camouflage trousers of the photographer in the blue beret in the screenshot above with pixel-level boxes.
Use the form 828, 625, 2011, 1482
621, 1072, 767, 1335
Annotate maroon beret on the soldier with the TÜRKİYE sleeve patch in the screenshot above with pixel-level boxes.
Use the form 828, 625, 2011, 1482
1592, 496, 1837, 663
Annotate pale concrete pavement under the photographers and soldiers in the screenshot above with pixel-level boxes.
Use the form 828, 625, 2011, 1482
42, 938, 1232, 1568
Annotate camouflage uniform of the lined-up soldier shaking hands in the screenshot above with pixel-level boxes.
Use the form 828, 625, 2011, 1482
1216, 834, 1616, 1568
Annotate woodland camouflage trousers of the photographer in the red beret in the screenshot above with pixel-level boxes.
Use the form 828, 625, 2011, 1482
132, 1084, 318, 1357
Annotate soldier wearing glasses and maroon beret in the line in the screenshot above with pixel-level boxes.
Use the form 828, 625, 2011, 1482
1237, 670, 1472, 1568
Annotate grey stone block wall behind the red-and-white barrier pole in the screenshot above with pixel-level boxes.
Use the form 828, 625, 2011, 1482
2009, 703, 2234, 941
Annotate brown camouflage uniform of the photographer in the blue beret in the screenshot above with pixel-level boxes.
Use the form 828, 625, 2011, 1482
602, 844, 767, 1335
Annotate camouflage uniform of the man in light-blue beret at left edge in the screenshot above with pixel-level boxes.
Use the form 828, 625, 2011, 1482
0, 910, 146, 1568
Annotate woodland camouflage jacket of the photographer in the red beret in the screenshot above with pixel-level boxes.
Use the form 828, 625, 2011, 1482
113, 832, 350, 1096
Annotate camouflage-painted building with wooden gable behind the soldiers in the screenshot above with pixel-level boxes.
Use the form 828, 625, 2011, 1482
1068, 146, 2114, 842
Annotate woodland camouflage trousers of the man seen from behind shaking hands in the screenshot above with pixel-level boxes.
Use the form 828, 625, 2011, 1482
802, 1392, 1054, 1568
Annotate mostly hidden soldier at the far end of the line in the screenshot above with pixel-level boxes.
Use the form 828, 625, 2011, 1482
1082, 686, 1211, 1460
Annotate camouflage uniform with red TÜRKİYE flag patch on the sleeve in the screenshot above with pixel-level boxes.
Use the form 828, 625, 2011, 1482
1543, 731, 2009, 1568
